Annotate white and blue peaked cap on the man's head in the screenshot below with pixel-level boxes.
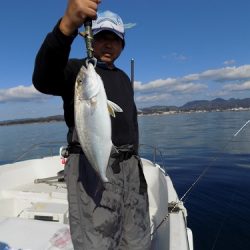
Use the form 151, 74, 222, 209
92, 11, 125, 39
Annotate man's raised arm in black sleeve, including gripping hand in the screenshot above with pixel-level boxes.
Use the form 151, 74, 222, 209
32, 0, 100, 95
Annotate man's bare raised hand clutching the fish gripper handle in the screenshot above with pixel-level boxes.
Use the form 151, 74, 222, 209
59, 0, 101, 36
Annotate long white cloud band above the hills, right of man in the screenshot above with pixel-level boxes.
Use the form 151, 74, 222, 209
134, 65, 250, 106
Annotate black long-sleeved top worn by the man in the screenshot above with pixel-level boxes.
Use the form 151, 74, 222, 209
33, 23, 138, 151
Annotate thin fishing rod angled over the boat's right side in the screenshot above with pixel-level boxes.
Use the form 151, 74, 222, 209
151, 120, 250, 236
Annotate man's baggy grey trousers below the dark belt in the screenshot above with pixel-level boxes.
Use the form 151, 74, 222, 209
65, 151, 151, 250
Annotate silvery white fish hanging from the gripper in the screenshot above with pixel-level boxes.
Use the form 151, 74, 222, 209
74, 62, 123, 182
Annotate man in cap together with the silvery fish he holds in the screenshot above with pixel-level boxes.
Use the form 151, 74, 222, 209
33, 0, 151, 250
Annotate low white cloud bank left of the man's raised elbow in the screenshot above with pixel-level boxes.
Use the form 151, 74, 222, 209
0, 85, 49, 103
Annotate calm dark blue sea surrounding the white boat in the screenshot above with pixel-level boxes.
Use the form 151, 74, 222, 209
0, 111, 250, 250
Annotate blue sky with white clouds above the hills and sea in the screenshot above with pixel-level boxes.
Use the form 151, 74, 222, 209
0, 0, 250, 120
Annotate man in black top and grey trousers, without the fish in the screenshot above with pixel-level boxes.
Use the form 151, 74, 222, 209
33, 0, 151, 250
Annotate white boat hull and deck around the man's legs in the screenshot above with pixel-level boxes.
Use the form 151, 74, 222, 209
0, 145, 193, 250
